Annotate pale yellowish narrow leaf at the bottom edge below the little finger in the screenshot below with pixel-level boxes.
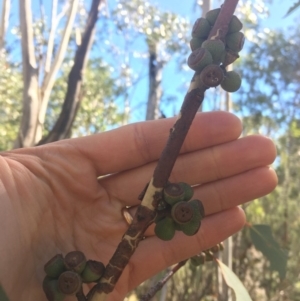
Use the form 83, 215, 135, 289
216, 259, 252, 301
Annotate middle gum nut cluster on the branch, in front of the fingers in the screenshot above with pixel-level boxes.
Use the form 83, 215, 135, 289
154, 182, 204, 240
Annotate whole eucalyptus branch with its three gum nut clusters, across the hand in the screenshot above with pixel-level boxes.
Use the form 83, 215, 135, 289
43, 0, 245, 301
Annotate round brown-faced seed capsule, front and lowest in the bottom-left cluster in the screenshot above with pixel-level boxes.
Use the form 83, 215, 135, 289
58, 271, 82, 295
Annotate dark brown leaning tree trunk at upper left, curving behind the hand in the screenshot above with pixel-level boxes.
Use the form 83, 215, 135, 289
38, 0, 102, 145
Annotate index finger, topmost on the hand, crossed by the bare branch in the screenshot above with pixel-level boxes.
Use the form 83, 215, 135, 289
65, 111, 242, 175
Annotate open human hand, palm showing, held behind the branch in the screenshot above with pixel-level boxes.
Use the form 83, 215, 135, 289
0, 112, 277, 301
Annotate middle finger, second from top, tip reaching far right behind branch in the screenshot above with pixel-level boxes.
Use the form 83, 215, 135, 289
100, 136, 276, 206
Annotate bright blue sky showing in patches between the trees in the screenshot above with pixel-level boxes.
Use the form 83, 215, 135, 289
0, 0, 299, 122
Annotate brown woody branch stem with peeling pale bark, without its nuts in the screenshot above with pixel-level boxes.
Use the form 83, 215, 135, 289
87, 0, 238, 301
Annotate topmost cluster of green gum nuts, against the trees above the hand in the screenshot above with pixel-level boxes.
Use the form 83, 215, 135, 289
187, 8, 245, 92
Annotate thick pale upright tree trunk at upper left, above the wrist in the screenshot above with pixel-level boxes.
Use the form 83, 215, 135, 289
14, 0, 39, 148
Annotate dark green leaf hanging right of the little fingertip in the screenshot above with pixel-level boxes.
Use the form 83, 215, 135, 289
250, 225, 288, 279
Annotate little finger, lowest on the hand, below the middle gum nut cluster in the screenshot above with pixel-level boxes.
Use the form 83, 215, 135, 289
124, 208, 245, 289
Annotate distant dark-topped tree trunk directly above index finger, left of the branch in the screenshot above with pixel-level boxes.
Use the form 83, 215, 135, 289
146, 42, 163, 120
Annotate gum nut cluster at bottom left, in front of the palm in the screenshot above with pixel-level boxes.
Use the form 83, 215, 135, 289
43, 251, 105, 301
